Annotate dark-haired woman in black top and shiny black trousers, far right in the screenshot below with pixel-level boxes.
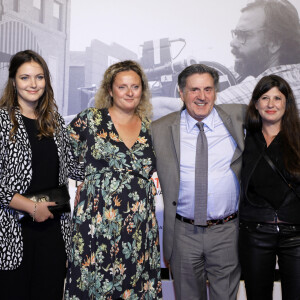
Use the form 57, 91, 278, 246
239, 75, 300, 300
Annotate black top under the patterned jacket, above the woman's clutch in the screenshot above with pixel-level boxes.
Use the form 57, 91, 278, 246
22, 116, 59, 194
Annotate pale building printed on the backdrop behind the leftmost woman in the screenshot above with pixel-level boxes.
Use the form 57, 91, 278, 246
0, 0, 71, 113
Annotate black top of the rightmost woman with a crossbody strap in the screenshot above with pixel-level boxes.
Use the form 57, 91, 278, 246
239, 131, 300, 224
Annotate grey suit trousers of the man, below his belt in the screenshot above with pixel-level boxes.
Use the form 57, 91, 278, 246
170, 219, 240, 300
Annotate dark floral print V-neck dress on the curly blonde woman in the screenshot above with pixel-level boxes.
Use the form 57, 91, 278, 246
65, 108, 162, 300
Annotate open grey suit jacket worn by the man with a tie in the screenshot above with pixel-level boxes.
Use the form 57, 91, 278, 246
152, 104, 247, 261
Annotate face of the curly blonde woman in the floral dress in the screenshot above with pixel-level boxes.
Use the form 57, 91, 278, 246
109, 70, 142, 112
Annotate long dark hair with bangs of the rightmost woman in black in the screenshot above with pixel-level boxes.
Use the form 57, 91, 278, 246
246, 75, 300, 178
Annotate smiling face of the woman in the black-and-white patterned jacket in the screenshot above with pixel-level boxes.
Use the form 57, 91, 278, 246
14, 61, 46, 108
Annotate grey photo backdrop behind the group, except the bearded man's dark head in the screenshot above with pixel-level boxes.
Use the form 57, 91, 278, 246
0, 0, 300, 299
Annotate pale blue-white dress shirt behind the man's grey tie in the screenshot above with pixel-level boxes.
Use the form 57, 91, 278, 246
177, 108, 239, 220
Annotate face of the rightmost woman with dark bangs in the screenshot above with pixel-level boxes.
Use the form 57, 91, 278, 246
255, 87, 286, 128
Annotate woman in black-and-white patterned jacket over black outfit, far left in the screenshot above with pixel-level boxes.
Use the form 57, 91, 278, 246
0, 50, 82, 300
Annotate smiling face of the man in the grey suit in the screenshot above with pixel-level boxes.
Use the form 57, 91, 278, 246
179, 73, 216, 121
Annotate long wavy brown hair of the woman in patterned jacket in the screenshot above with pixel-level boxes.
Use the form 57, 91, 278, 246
0, 50, 58, 140
